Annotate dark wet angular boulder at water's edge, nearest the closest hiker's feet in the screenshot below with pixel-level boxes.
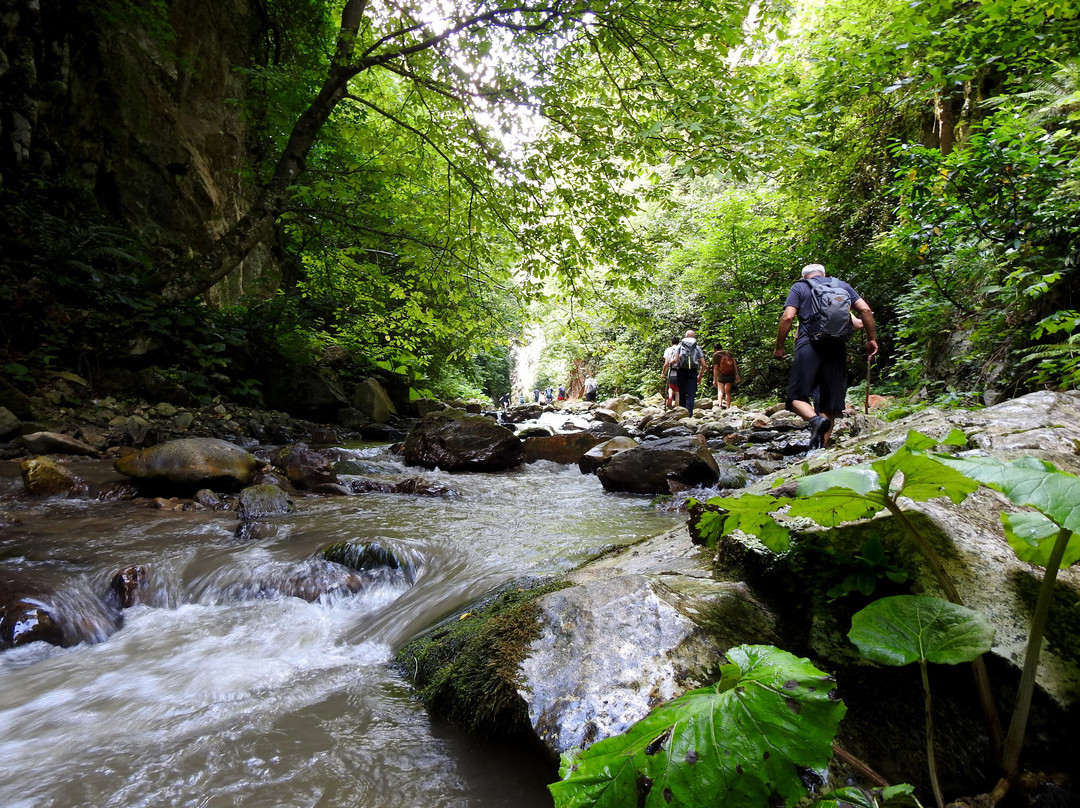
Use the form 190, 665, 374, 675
596, 436, 719, 494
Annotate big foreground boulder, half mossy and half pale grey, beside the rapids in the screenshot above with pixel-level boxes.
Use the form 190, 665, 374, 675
397, 528, 779, 758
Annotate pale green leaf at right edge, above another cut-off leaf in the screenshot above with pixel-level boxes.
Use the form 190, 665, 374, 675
940, 456, 1080, 533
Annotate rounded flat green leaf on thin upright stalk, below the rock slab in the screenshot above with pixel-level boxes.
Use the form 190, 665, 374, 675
848, 595, 994, 665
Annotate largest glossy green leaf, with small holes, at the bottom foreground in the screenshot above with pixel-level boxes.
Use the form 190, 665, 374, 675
549, 646, 846, 808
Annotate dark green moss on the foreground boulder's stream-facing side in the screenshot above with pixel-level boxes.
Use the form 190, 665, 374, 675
396, 579, 571, 736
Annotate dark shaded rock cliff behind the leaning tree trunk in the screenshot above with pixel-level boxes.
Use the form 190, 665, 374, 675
0, 0, 278, 297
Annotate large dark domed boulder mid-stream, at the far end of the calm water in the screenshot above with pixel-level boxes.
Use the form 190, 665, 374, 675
403, 409, 525, 471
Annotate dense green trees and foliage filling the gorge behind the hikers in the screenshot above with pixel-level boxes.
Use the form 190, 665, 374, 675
0, 0, 1080, 403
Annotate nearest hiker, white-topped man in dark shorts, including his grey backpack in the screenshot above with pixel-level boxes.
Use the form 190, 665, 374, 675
772, 264, 878, 449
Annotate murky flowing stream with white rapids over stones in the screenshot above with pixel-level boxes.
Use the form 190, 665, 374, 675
0, 446, 683, 808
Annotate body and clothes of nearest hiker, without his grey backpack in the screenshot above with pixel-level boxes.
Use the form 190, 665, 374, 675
772, 264, 878, 449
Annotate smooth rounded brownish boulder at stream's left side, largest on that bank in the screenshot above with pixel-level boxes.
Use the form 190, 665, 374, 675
112, 437, 258, 491
